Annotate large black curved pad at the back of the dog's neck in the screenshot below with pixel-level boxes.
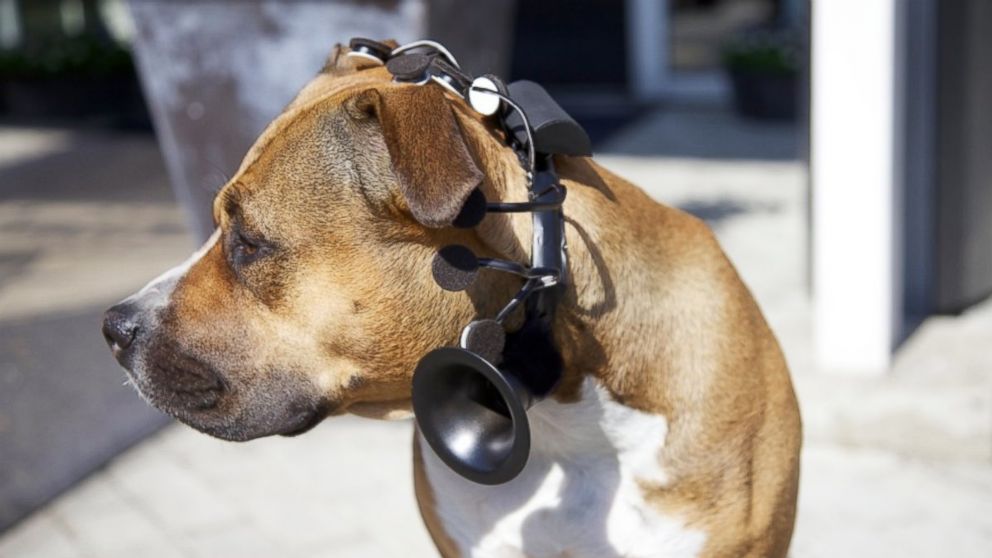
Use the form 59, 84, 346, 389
506, 80, 592, 157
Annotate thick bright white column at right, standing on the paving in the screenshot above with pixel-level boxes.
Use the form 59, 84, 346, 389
811, 0, 902, 374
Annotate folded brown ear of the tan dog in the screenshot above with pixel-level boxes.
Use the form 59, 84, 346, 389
354, 85, 483, 227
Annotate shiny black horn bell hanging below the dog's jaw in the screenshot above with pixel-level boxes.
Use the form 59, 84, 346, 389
413, 347, 533, 485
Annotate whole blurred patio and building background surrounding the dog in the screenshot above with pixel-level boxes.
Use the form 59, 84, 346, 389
0, 0, 992, 558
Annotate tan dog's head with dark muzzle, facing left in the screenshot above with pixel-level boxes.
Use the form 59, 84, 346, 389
103, 44, 528, 440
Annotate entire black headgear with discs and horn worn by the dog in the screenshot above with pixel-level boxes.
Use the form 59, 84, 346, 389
348, 39, 591, 484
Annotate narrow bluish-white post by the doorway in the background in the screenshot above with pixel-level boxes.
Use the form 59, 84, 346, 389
626, 0, 668, 101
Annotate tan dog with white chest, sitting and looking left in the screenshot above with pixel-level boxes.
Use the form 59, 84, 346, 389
103, 41, 801, 557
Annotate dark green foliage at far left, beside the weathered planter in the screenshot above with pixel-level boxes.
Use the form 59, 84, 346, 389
0, 35, 134, 80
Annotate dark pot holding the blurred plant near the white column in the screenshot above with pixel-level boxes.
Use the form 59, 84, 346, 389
730, 70, 799, 120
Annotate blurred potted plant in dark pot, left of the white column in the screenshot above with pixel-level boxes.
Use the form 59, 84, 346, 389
723, 29, 804, 120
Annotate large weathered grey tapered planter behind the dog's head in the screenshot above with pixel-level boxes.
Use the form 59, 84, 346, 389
130, 0, 514, 243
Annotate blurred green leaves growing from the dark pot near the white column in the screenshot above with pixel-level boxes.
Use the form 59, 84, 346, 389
723, 30, 803, 75
